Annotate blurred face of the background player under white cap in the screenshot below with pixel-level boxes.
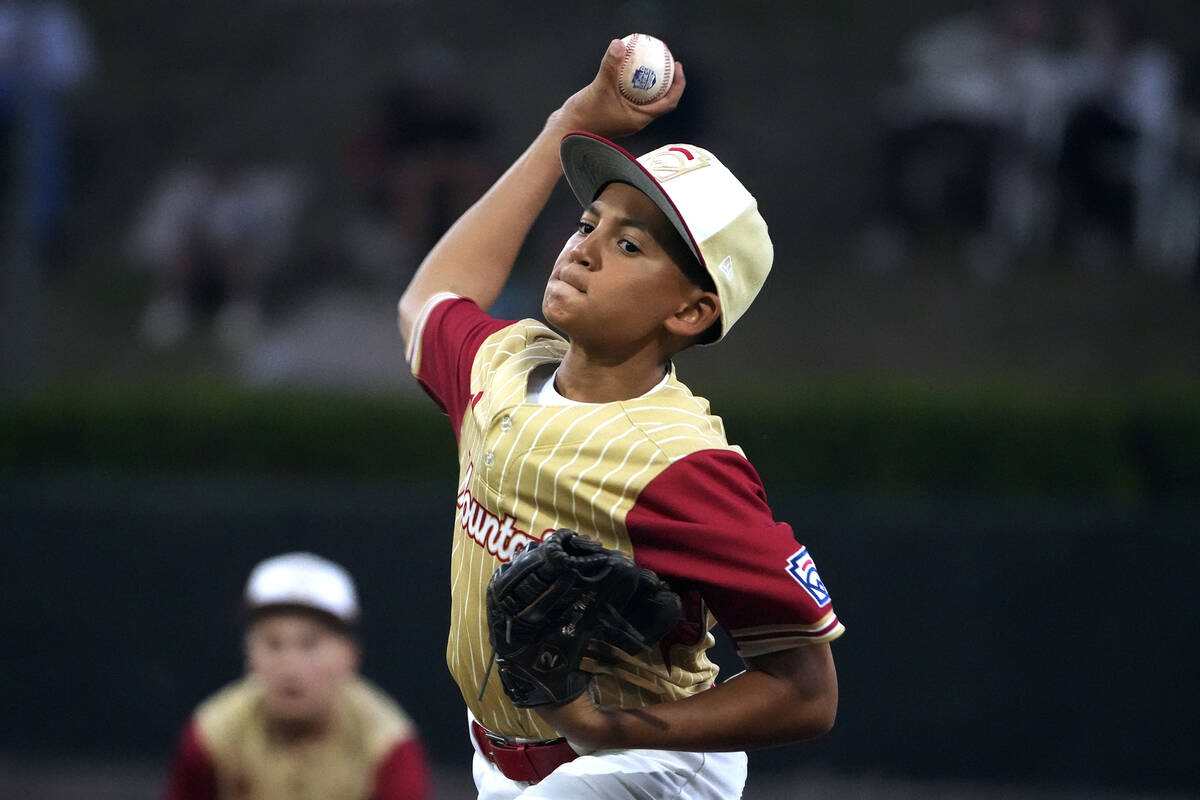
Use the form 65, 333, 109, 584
246, 614, 358, 723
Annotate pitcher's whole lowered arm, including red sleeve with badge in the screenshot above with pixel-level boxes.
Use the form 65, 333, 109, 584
538, 450, 844, 751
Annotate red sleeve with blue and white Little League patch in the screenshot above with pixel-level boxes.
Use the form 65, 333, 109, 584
625, 450, 842, 655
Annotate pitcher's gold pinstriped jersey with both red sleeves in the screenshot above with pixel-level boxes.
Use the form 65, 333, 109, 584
407, 294, 844, 739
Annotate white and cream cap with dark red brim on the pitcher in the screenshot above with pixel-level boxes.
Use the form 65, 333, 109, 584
559, 131, 774, 339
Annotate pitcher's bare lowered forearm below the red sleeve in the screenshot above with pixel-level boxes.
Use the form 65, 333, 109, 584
538, 643, 838, 751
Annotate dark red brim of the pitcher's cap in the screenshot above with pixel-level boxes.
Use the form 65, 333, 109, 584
558, 131, 707, 269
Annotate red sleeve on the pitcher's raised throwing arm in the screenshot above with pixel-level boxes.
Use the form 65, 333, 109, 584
408, 295, 511, 437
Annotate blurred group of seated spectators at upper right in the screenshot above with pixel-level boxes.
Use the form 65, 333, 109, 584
864, 0, 1200, 282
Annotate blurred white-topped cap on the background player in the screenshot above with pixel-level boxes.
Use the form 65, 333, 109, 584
244, 553, 359, 627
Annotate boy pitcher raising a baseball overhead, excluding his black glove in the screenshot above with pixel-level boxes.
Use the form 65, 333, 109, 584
400, 41, 842, 800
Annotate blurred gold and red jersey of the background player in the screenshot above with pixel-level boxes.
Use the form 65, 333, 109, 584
166, 676, 430, 800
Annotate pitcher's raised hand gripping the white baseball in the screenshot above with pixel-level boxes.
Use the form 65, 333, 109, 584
550, 38, 688, 139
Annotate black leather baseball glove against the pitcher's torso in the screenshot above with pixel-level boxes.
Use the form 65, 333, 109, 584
487, 528, 680, 708
